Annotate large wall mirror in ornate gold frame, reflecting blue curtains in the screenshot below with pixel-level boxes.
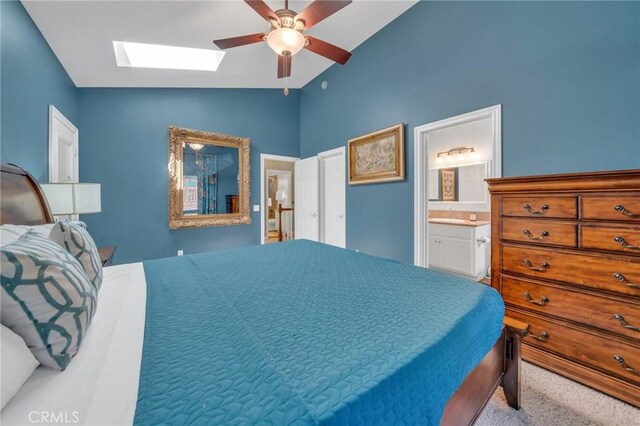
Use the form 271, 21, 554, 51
169, 126, 251, 229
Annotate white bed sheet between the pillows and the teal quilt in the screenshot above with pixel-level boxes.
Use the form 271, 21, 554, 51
0, 263, 147, 426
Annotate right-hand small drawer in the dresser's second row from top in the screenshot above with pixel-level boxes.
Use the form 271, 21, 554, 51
580, 225, 640, 255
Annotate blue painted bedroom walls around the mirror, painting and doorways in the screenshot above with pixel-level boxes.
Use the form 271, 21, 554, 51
0, 2, 640, 263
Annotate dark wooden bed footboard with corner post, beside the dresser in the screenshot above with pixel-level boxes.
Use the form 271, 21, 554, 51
440, 317, 529, 426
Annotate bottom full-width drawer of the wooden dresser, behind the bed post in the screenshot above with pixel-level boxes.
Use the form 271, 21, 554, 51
507, 309, 640, 384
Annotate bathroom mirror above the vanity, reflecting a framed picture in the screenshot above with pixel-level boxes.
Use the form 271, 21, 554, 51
427, 162, 489, 203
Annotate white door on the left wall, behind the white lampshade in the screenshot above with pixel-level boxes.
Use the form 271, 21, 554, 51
49, 105, 78, 183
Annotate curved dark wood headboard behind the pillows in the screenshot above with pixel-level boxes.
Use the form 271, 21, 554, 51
0, 164, 53, 225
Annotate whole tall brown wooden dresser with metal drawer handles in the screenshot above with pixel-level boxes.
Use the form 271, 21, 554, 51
488, 170, 640, 407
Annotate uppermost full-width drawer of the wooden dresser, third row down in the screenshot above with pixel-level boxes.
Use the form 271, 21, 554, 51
500, 244, 640, 297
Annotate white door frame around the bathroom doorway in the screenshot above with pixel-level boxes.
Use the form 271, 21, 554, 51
413, 104, 502, 268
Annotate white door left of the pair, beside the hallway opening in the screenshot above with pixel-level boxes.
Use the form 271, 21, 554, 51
294, 157, 320, 241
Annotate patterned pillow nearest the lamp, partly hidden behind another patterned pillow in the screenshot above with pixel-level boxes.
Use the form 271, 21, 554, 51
49, 221, 102, 291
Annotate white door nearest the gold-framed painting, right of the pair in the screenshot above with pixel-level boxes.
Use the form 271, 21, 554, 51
318, 148, 347, 248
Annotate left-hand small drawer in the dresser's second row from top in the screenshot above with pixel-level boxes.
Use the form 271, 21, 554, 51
500, 218, 578, 247
